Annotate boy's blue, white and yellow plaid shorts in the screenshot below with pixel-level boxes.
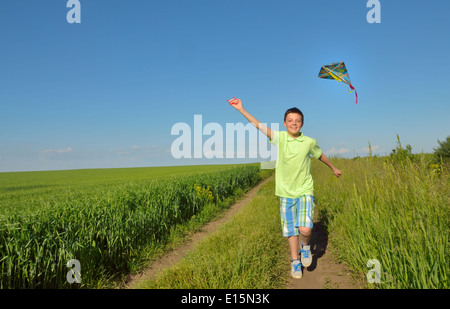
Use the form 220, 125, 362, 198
280, 195, 314, 237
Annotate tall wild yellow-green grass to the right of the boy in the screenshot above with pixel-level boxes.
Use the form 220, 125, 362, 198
312, 155, 450, 288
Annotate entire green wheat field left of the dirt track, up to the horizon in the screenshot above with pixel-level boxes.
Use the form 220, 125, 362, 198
0, 165, 260, 288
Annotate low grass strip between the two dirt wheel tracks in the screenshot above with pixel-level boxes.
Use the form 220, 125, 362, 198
138, 178, 289, 289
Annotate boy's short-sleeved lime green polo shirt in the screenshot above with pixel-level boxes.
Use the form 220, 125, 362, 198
270, 130, 322, 198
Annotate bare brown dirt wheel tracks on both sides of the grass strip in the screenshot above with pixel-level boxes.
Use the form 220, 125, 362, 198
125, 176, 359, 289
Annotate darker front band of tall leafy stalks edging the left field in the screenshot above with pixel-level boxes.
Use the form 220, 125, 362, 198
0, 165, 260, 288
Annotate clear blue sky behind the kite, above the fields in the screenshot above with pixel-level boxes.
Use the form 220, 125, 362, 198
0, 0, 450, 172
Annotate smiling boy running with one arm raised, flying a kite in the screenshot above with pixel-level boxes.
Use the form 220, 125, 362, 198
229, 99, 341, 278
